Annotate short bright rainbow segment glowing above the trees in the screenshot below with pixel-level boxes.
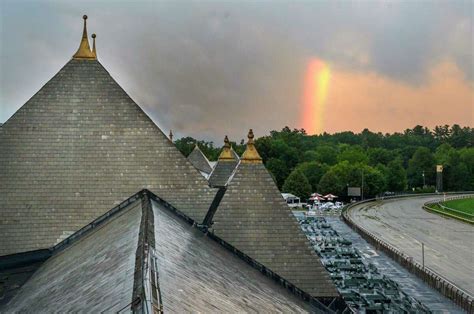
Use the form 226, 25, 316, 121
301, 59, 331, 134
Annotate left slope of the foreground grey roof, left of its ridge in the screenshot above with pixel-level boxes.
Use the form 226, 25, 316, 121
0, 200, 142, 313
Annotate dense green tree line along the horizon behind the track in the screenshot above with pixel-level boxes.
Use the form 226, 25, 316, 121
175, 124, 474, 199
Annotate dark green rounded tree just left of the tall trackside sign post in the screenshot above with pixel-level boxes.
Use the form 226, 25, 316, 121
407, 147, 436, 187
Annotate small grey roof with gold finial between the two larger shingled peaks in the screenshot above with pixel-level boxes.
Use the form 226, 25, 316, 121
208, 136, 239, 187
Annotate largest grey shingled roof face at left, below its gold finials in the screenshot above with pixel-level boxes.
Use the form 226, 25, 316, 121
0, 59, 216, 256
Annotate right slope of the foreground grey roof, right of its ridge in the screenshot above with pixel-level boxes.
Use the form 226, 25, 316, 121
153, 202, 309, 313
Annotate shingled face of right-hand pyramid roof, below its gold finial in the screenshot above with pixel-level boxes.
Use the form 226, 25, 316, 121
212, 162, 338, 298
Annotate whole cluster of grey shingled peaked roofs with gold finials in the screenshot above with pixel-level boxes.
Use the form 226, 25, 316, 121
0, 18, 344, 312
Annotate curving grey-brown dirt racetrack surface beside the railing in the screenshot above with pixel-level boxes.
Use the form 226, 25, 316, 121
347, 195, 474, 296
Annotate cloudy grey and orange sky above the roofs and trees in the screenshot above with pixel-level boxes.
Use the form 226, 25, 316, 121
0, 0, 474, 142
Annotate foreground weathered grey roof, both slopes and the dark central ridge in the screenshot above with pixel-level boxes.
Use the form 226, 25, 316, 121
0, 190, 321, 313
